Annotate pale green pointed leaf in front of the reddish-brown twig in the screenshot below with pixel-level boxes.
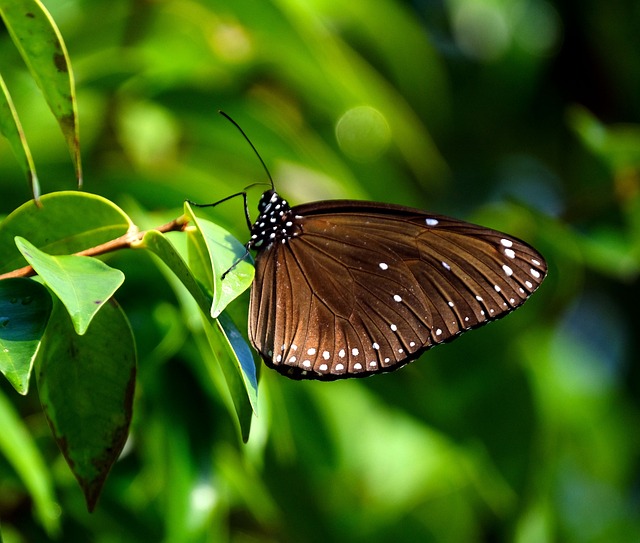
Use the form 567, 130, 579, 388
16, 236, 124, 335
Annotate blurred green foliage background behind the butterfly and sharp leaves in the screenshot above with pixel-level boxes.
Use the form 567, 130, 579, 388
0, 0, 640, 543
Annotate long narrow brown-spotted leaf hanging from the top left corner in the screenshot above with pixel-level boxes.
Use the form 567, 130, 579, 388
0, 0, 82, 186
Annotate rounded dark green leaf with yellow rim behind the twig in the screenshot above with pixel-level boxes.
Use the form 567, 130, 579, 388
0, 191, 133, 272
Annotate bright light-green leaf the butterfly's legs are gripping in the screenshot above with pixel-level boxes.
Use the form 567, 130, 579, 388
184, 202, 255, 318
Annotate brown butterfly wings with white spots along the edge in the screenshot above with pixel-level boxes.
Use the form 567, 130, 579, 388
249, 201, 547, 380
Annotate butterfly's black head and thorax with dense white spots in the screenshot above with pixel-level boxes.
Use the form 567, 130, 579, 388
247, 190, 302, 251
